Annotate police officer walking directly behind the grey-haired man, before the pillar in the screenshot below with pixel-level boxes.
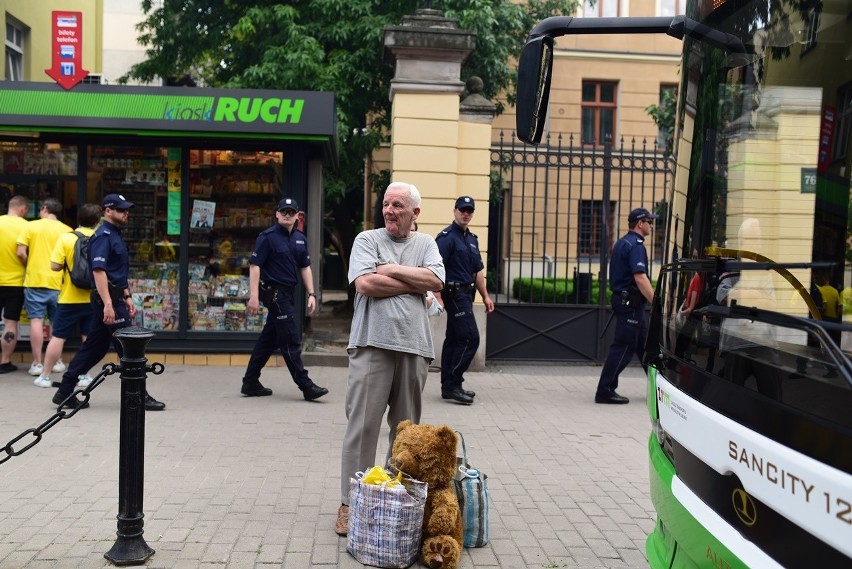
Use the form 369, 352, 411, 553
435, 196, 494, 405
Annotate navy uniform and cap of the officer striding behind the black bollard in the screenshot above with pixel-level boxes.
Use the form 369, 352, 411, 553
54, 194, 166, 411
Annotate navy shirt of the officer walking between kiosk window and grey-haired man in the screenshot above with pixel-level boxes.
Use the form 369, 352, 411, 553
249, 223, 311, 286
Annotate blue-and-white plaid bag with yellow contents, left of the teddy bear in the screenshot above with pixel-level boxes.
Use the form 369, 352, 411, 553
346, 472, 427, 568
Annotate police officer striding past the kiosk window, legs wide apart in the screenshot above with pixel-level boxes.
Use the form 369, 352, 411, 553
240, 198, 328, 401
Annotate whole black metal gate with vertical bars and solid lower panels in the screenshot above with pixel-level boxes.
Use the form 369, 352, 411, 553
486, 132, 672, 362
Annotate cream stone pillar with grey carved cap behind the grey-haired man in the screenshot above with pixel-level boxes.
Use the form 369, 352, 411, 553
385, 9, 494, 370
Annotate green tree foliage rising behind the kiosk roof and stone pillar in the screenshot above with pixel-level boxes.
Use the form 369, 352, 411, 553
123, 0, 576, 290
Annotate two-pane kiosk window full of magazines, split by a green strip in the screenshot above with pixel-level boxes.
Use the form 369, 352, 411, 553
90, 147, 283, 332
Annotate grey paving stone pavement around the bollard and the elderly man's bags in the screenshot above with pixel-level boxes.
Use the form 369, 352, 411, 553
0, 365, 655, 569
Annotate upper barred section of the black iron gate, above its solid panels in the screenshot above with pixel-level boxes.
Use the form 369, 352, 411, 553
488, 132, 672, 304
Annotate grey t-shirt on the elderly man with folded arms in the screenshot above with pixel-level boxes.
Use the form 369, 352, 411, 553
348, 229, 446, 360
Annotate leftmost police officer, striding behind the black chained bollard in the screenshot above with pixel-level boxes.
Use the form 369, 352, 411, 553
53, 194, 166, 411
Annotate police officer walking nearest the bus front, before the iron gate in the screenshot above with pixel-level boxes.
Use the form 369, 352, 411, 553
595, 207, 657, 404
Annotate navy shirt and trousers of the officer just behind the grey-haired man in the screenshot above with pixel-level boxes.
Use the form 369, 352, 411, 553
435, 211, 484, 394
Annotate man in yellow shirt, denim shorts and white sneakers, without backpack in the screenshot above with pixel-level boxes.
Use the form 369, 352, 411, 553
17, 198, 71, 377
